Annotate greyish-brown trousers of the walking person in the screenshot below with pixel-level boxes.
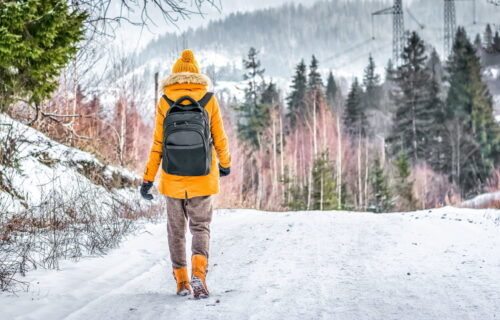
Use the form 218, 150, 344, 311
167, 196, 212, 269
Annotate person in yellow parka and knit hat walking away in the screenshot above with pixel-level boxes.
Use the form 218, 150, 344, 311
140, 50, 231, 298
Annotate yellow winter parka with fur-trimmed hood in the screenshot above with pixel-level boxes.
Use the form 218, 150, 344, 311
144, 72, 231, 199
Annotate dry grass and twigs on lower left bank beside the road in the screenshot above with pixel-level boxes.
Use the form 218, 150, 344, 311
0, 189, 165, 292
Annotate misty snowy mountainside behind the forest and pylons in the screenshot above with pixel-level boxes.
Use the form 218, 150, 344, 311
137, 0, 500, 80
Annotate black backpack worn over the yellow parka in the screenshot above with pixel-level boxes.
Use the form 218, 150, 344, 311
162, 92, 213, 176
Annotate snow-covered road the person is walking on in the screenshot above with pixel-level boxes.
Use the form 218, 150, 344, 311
0, 208, 500, 320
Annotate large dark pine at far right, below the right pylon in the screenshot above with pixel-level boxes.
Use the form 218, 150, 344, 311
446, 28, 500, 193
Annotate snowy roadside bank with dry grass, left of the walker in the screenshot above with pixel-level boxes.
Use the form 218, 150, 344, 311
0, 114, 163, 291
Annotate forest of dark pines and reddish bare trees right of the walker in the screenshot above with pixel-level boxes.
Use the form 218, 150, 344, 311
224, 27, 500, 212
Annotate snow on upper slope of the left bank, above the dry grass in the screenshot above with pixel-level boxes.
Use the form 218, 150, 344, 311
0, 114, 148, 215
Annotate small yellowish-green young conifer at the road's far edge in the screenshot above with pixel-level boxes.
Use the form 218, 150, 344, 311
312, 151, 339, 210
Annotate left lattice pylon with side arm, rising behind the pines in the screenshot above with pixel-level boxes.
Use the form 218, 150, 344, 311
372, 0, 405, 66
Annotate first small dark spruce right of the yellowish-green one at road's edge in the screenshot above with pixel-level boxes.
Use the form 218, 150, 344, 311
368, 156, 394, 213
